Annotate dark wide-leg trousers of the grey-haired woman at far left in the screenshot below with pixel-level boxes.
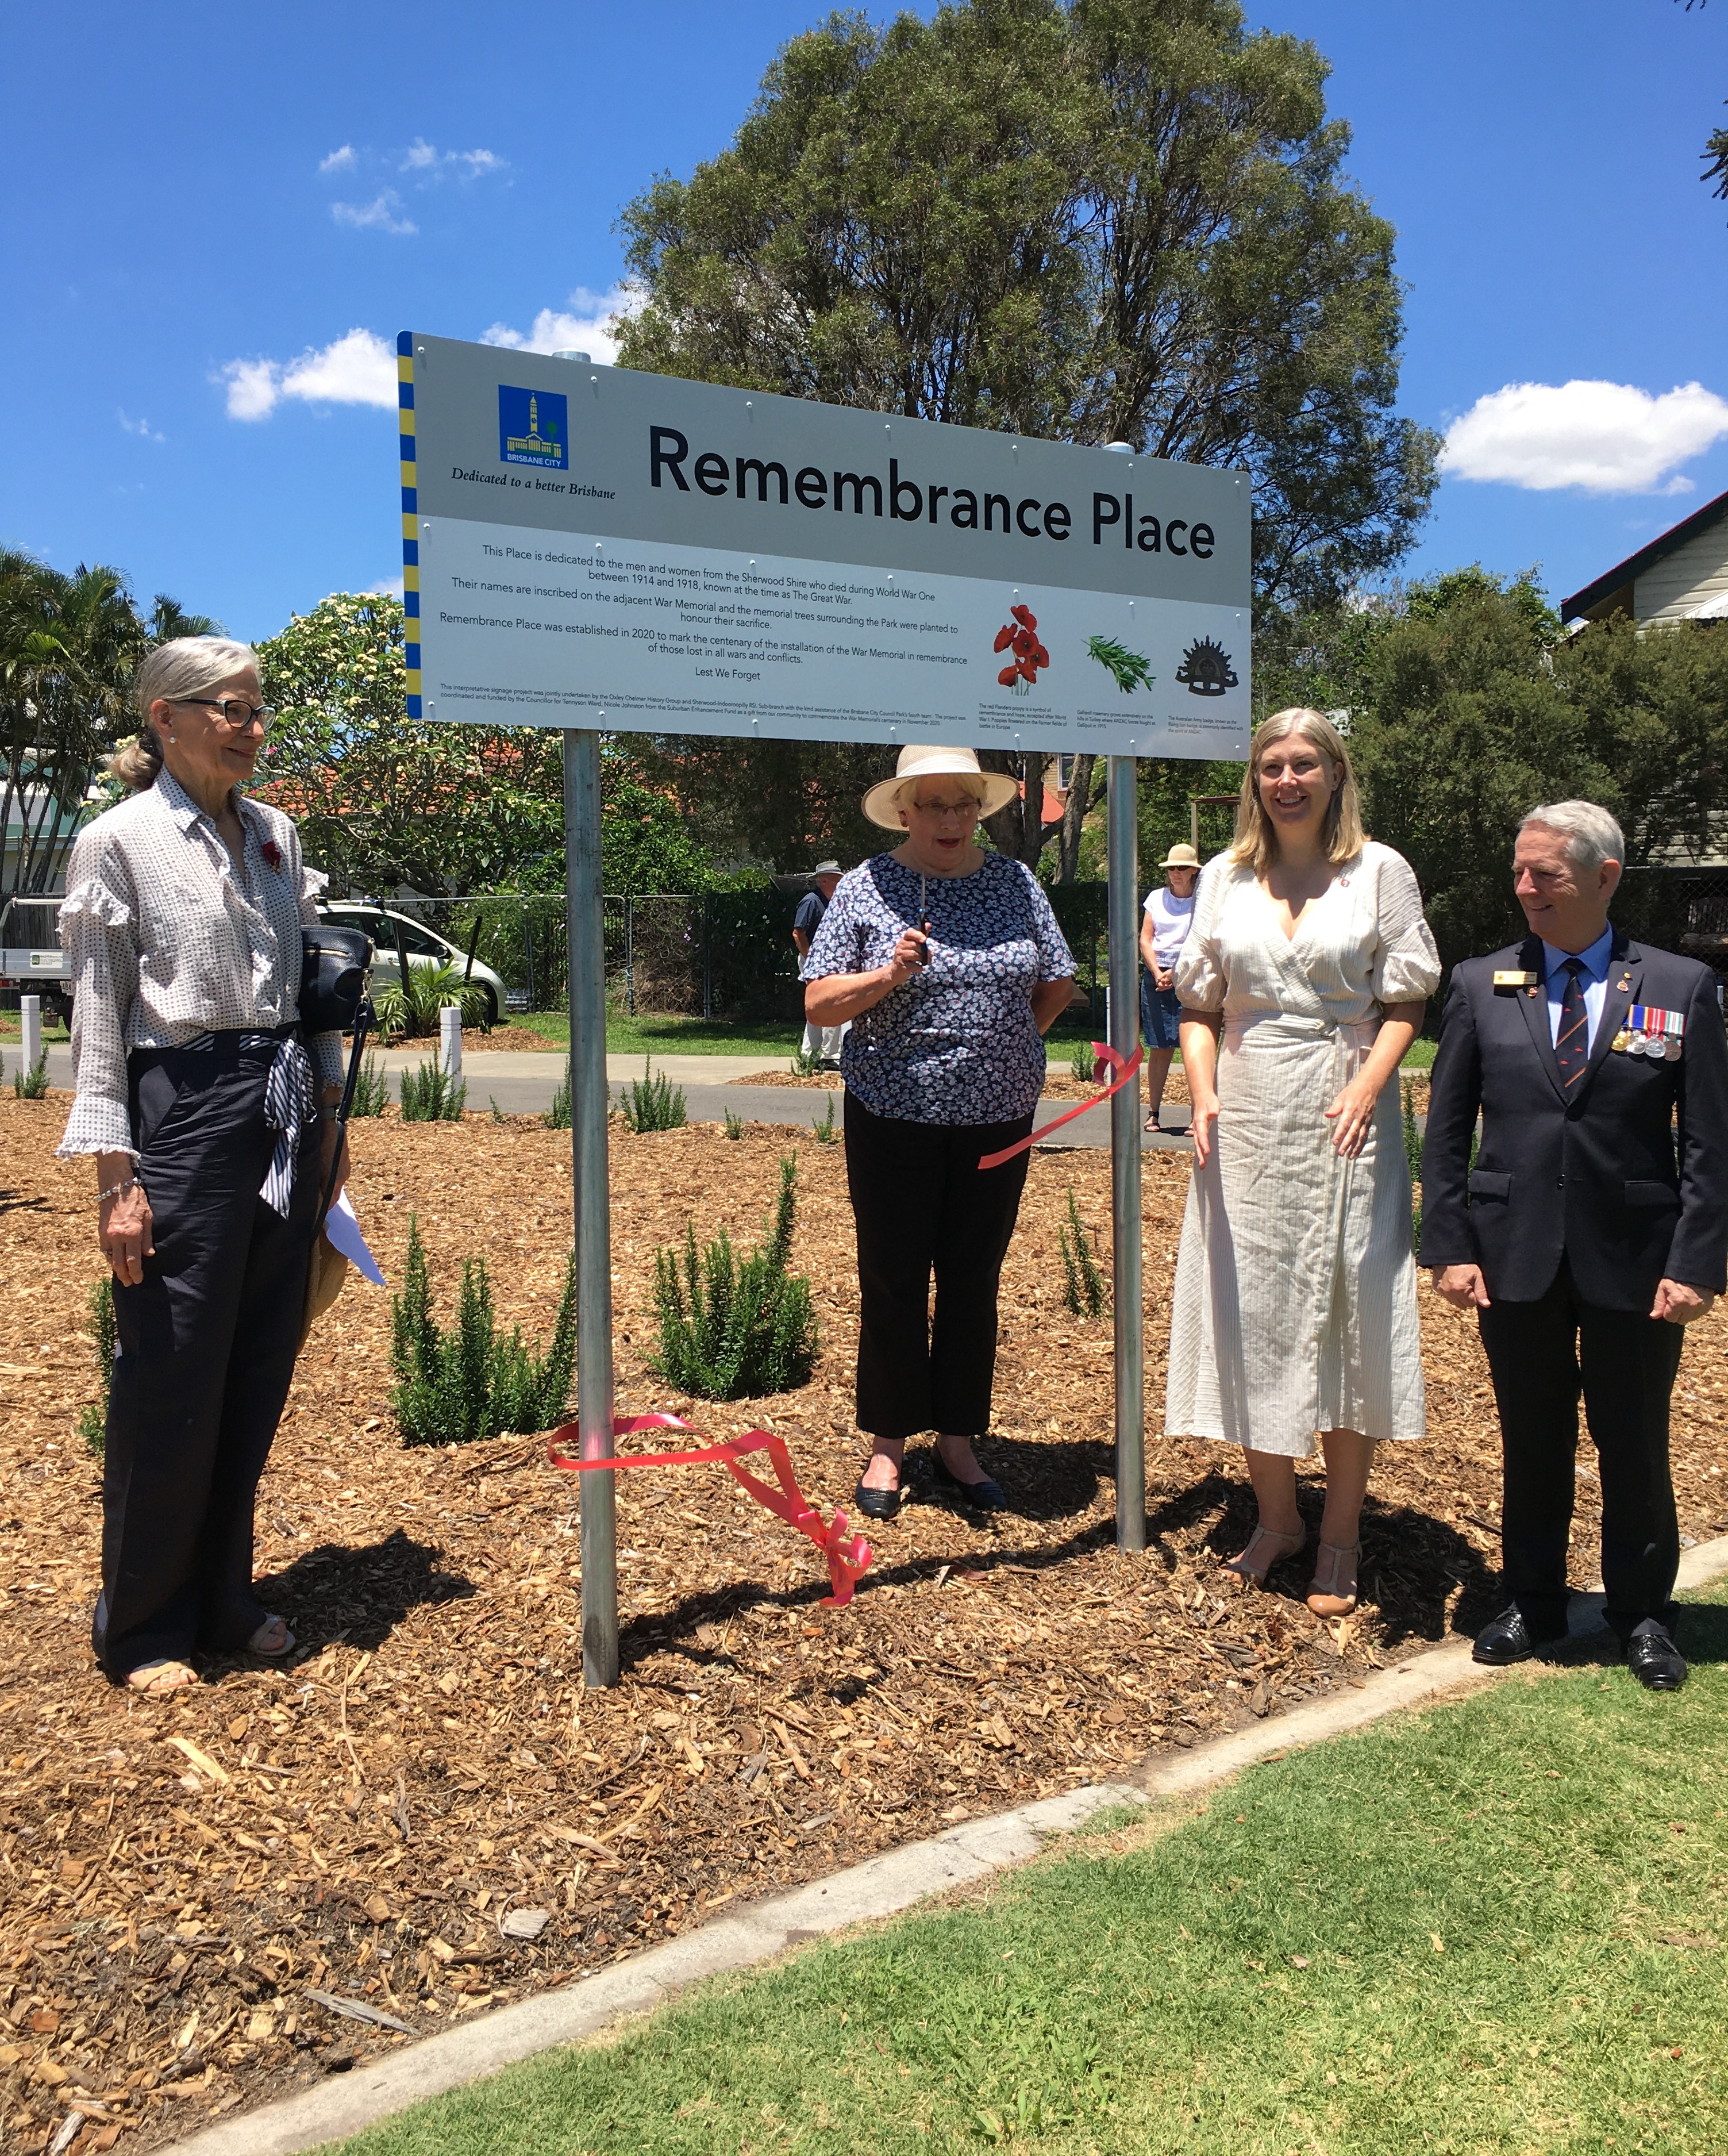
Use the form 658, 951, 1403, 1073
93, 1042, 321, 1682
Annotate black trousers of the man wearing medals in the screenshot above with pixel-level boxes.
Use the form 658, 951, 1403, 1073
1480, 1259, 1683, 1639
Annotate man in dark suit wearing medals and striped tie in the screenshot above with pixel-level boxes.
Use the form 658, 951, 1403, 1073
1422, 802, 1728, 1690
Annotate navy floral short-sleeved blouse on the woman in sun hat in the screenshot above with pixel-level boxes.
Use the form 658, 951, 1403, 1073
799, 854, 1077, 1123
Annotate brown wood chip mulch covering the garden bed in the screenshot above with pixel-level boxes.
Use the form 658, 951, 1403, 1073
0, 1096, 1728, 2156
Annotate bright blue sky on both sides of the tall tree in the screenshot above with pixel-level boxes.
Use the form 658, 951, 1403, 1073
0, 0, 1728, 636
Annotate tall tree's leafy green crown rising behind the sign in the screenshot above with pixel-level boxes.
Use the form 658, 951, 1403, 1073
621, 0, 1437, 616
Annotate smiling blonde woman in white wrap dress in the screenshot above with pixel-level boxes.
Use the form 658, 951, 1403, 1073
1164, 709, 1440, 1617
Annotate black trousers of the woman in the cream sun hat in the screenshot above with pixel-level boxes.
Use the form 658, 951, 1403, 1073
847, 1093, 1032, 1438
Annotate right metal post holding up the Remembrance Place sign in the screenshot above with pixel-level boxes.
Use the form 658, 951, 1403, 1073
1105, 757, 1146, 1550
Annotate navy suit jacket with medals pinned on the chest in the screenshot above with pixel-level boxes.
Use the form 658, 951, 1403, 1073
1422, 929, 1728, 1311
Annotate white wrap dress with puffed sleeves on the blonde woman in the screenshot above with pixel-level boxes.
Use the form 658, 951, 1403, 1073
1164, 841, 1440, 1458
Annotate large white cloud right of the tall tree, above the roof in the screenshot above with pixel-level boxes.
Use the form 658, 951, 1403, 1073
1440, 382, 1728, 494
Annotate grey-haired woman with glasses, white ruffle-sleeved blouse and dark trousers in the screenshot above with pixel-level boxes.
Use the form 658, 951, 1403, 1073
60, 636, 342, 1693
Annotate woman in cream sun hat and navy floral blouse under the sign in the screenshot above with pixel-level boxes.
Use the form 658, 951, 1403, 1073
804, 748, 1075, 1520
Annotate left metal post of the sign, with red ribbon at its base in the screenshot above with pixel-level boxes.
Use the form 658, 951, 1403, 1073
564, 729, 618, 1688
